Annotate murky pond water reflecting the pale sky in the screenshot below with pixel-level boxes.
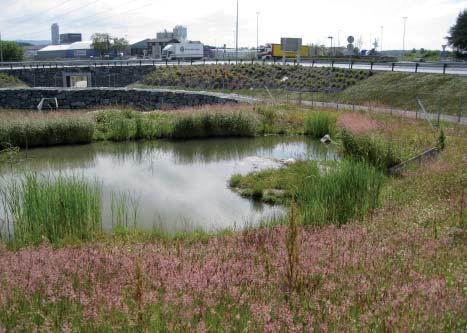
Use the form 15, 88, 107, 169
0, 136, 336, 231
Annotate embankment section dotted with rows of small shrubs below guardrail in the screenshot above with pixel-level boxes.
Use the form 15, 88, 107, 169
142, 64, 371, 91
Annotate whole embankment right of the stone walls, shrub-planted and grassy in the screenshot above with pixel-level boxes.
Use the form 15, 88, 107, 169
141, 65, 467, 116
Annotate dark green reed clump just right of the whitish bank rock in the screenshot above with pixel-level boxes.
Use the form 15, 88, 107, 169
341, 130, 402, 170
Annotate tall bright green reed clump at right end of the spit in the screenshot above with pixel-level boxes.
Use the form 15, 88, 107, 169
296, 160, 384, 226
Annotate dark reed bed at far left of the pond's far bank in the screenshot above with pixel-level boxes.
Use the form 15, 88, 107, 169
0, 117, 94, 148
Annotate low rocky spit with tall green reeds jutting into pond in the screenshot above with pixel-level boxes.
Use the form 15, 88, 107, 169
230, 160, 384, 226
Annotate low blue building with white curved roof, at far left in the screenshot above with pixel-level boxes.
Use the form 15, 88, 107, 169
37, 41, 98, 59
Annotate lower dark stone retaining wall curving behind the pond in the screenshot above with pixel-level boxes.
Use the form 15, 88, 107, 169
0, 88, 238, 110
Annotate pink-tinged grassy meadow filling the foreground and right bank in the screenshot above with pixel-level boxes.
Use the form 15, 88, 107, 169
0, 109, 467, 332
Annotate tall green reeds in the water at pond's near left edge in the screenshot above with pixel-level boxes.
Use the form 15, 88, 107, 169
0, 174, 102, 247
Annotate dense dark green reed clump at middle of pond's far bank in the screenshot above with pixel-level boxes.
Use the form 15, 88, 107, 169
171, 112, 257, 139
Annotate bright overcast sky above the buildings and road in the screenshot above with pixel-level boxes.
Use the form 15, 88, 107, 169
0, 0, 467, 49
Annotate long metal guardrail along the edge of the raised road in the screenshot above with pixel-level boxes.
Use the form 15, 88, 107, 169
0, 59, 467, 75
